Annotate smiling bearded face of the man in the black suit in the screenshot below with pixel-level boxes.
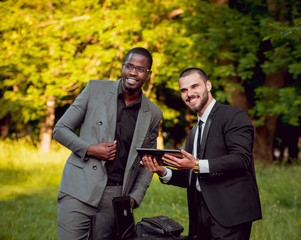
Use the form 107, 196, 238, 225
179, 72, 213, 116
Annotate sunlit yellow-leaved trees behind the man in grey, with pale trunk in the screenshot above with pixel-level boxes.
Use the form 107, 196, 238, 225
0, 0, 188, 150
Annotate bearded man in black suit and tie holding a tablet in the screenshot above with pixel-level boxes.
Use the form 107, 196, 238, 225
141, 68, 262, 240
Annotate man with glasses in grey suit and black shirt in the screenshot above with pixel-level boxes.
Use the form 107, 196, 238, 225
53, 47, 162, 240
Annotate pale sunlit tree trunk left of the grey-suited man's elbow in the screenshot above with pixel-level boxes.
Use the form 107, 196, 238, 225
40, 96, 55, 152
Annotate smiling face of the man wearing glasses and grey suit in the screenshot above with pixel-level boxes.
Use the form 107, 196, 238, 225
122, 53, 152, 93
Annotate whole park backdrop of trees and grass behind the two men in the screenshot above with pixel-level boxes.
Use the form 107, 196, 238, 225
0, 0, 301, 240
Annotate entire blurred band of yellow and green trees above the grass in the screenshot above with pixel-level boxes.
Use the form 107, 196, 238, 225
0, 0, 301, 164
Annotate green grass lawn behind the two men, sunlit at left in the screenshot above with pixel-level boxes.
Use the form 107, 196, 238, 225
0, 141, 301, 240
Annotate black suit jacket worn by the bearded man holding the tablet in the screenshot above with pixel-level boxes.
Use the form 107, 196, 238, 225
168, 102, 261, 235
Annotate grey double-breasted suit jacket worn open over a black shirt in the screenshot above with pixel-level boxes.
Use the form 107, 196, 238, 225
53, 79, 162, 206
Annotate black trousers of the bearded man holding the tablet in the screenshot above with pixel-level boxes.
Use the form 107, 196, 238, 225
196, 190, 252, 240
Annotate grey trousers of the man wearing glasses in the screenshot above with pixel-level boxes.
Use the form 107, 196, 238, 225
57, 186, 122, 240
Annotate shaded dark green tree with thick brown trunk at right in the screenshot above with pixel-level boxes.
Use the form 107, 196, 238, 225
178, 0, 301, 164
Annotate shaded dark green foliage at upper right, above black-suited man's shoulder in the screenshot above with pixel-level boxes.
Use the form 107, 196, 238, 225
180, 1, 301, 130
